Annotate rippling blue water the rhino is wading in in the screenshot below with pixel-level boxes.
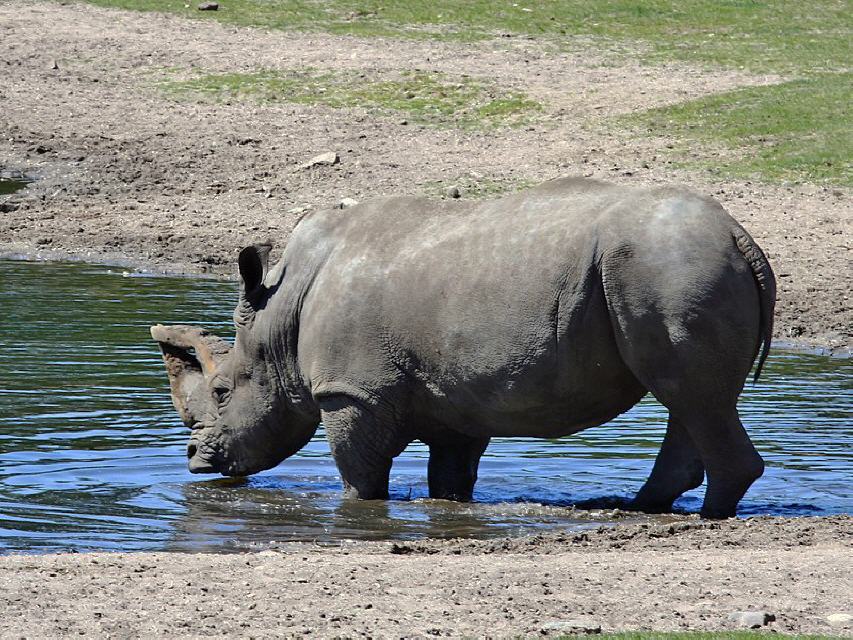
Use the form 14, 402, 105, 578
0, 260, 853, 553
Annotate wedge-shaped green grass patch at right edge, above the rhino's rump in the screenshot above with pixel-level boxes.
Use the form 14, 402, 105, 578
620, 73, 853, 186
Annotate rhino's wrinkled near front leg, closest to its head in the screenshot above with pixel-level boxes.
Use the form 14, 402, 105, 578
320, 395, 408, 500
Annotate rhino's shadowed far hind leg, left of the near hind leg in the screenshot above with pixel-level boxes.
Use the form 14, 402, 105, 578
631, 415, 705, 513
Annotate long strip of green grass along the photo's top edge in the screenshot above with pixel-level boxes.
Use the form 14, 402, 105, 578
78, 0, 853, 73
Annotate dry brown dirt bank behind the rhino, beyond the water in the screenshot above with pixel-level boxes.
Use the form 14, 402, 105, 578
0, 0, 853, 349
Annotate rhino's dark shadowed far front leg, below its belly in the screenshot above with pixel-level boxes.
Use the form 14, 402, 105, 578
427, 434, 489, 502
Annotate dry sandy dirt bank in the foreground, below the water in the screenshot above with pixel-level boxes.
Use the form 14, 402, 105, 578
0, 516, 853, 638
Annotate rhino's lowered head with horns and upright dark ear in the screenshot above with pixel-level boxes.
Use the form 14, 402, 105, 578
151, 245, 317, 476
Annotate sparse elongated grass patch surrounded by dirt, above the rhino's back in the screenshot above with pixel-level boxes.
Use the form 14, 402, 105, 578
162, 70, 541, 128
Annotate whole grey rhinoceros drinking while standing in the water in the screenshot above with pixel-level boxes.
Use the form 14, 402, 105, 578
151, 178, 775, 517
